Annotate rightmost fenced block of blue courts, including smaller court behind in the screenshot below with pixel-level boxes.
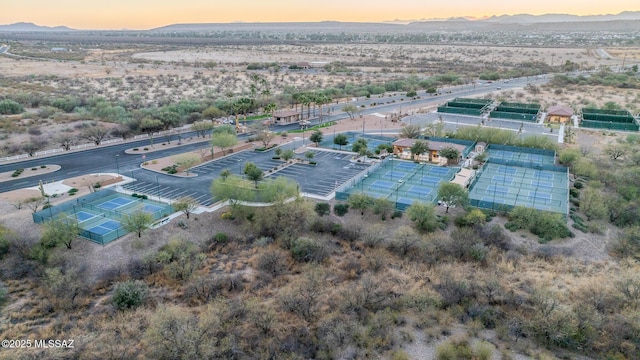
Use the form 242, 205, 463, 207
469, 145, 569, 217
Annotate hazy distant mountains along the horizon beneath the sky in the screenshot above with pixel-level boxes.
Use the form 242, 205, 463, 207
0, 11, 640, 32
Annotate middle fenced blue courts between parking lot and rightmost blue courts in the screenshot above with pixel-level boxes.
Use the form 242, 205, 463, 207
336, 159, 460, 210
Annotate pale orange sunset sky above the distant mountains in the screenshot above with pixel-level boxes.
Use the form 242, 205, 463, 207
0, 0, 640, 29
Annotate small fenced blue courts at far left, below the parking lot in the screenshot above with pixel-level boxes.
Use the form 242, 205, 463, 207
33, 189, 174, 245
